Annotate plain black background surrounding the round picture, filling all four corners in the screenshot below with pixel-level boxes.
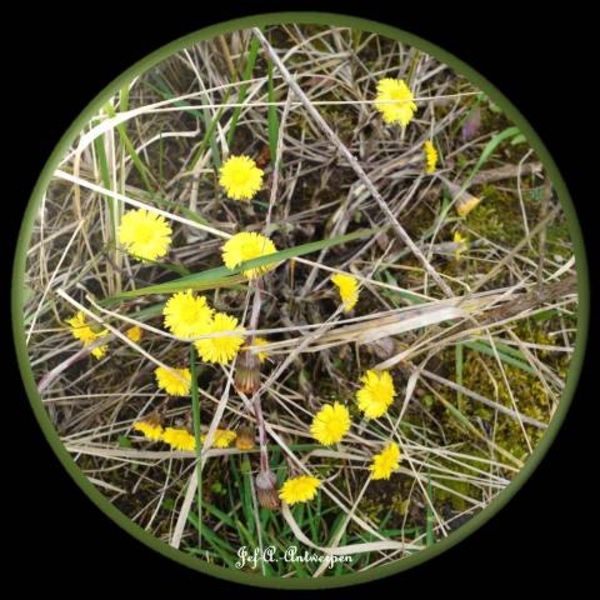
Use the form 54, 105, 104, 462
5, 2, 600, 598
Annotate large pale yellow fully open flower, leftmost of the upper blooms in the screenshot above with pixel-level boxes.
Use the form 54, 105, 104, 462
118, 208, 173, 260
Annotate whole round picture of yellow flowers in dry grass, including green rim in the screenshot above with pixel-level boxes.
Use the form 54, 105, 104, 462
13, 13, 588, 589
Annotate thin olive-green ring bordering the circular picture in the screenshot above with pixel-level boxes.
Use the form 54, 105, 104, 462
11, 12, 589, 589
